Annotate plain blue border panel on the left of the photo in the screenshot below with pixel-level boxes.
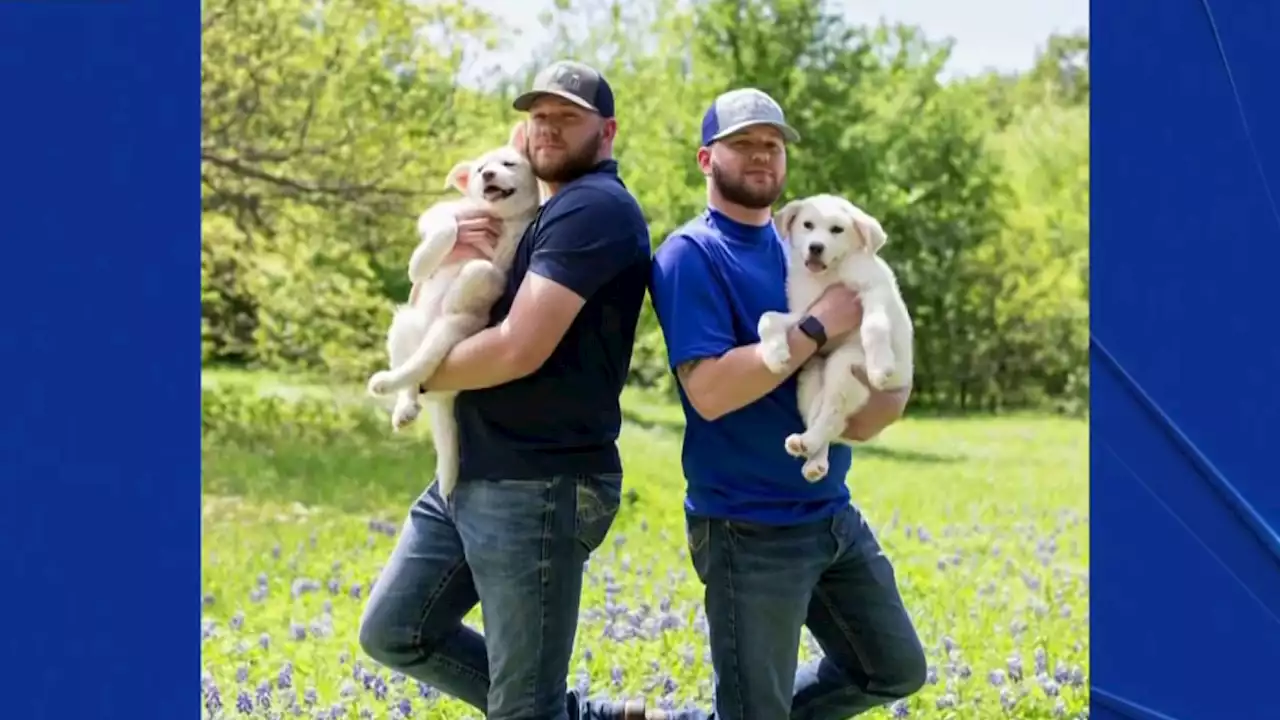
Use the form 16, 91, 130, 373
0, 0, 200, 720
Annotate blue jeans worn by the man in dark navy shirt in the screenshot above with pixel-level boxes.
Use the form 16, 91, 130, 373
360, 475, 634, 720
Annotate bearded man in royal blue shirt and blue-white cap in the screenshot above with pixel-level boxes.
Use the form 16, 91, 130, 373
649, 88, 925, 720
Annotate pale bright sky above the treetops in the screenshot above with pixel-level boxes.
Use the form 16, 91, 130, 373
471, 0, 1089, 77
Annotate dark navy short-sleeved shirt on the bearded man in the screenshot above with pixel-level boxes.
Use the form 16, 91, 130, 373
456, 160, 652, 479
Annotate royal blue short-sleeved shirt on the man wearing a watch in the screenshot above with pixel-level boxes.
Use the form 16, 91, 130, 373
649, 209, 852, 525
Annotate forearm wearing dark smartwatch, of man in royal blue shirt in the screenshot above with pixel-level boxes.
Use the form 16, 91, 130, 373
676, 328, 818, 420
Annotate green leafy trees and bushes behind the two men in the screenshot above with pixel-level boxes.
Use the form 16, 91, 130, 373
201, 0, 1089, 413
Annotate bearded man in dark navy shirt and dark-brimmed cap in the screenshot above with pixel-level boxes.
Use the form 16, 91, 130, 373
360, 63, 650, 720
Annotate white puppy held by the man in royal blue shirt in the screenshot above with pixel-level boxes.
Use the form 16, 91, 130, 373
756, 195, 915, 482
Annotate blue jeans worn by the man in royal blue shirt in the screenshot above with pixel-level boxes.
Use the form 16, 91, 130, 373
676, 506, 927, 720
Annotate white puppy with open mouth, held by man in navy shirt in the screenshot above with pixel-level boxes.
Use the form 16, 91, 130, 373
369, 124, 541, 497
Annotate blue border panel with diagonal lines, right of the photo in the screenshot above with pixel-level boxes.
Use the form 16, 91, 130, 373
1089, 0, 1280, 720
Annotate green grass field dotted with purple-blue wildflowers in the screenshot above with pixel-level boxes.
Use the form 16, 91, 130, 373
201, 372, 1089, 720
